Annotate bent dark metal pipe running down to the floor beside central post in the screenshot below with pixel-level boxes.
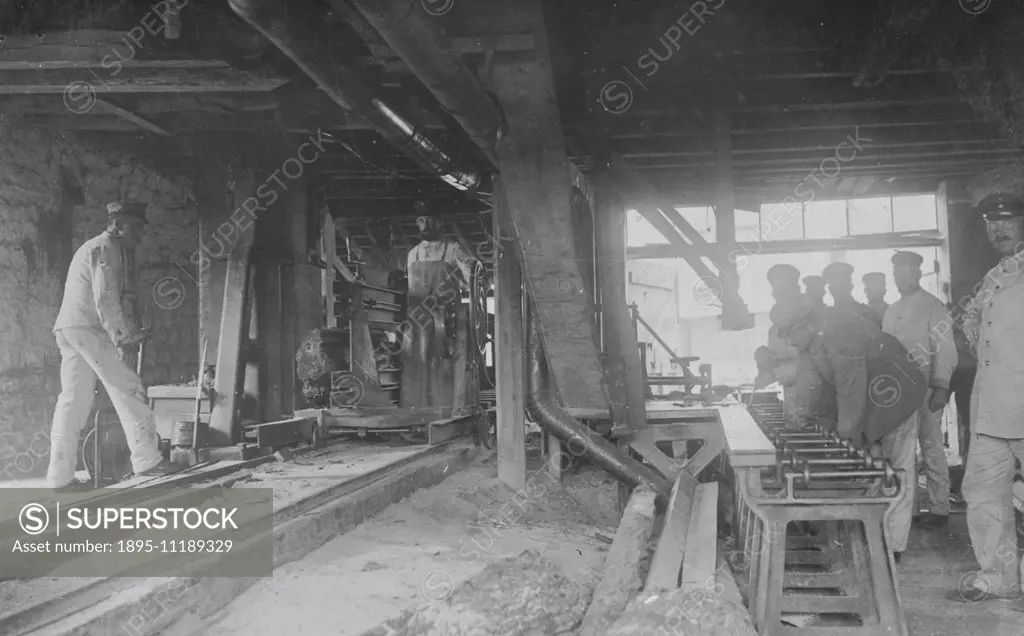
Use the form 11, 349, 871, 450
526, 303, 672, 501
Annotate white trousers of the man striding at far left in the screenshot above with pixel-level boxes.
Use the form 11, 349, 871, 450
46, 327, 162, 487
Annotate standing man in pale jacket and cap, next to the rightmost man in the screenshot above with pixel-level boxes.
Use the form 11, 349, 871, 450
882, 252, 956, 554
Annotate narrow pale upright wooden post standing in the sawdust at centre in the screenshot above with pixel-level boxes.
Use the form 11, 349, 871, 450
493, 181, 526, 490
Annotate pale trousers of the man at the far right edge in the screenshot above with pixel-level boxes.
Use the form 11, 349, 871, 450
961, 433, 1024, 596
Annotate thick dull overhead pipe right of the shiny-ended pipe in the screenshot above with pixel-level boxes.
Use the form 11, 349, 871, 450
344, 0, 503, 165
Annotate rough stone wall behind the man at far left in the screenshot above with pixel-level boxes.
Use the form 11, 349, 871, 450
0, 122, 199, 480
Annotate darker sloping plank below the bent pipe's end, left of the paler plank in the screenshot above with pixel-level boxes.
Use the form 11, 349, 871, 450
644, 470, 697, 593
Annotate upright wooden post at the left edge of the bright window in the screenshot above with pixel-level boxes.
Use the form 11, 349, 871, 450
596, 186, 647, 430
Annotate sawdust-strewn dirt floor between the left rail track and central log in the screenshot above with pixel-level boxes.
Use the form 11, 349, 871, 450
195, 448, 618, 636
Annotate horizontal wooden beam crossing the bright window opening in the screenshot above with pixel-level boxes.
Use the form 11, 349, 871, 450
626, 230, 945, 260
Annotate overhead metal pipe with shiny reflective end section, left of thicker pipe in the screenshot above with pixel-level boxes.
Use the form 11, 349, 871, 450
228, 0, 481, 192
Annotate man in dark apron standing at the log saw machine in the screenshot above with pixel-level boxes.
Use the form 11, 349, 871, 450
400, 202, 475, 410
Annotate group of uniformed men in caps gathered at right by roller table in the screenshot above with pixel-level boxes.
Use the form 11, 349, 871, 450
755, 194, 1024, 611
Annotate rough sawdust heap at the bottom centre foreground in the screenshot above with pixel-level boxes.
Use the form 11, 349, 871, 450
362, 550, 593, 636
